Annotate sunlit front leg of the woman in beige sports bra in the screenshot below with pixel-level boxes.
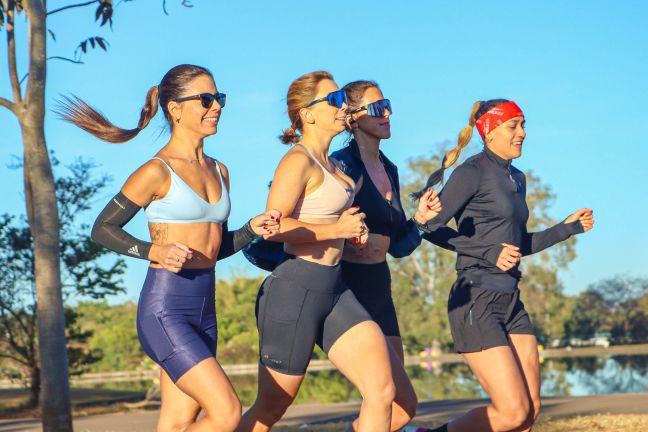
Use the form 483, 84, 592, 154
328, 321, 395, 432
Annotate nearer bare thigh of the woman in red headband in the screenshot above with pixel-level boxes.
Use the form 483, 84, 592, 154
462, 345, 528, 411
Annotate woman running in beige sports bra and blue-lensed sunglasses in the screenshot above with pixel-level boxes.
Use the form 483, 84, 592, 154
238, 71, 394, 432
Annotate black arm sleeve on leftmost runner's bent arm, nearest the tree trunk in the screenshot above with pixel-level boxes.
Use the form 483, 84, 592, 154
92, 192, 152, 260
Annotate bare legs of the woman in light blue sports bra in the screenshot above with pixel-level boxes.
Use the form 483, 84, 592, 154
158, 357, 241, 432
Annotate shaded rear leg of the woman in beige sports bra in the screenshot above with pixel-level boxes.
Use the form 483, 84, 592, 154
236, 364, 304, 432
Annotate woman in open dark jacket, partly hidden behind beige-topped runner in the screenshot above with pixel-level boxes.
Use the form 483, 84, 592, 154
331, 81, 520, 431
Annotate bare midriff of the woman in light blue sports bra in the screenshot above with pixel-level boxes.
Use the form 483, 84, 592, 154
149, 222, 223, 269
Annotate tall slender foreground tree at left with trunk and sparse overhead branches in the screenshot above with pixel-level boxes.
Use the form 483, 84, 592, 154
0, 0, 192, 431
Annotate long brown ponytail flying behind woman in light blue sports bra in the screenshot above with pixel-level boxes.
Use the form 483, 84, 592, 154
55, 86, 159, 143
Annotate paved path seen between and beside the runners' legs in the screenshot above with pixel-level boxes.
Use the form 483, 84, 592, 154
0, 394, 648, 432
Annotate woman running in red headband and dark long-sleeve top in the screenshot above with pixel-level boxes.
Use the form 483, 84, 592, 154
412, 99, 594, 432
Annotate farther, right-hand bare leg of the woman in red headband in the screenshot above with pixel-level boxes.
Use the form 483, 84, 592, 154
509, 334, 540, 432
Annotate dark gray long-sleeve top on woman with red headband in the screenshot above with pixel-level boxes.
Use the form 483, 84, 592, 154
424, 147, 583, 279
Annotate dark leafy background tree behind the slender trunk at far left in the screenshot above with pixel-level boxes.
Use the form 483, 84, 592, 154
0, 158, 126, 406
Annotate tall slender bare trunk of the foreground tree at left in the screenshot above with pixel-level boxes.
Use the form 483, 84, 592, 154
18, 0, 72, 432
